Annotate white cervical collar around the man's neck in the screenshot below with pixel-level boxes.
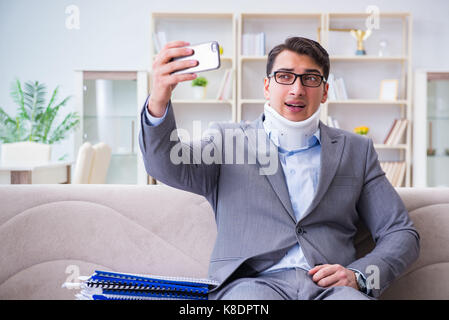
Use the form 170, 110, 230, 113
263, 101, 321, 151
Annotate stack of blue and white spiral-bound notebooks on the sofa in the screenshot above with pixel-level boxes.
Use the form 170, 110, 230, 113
76, 270, 218, 300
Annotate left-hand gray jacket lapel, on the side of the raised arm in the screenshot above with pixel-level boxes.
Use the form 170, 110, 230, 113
242, 114, 296, 223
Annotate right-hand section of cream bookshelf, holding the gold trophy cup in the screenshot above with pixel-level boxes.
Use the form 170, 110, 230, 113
320, 13, 412, 187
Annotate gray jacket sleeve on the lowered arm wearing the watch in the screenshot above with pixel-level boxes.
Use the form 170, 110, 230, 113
347, 139, 419, 297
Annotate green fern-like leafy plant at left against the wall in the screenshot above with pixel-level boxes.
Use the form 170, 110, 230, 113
0, 80, 80, 160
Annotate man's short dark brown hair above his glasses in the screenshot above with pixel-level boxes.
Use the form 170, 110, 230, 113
267, 37, 330, 79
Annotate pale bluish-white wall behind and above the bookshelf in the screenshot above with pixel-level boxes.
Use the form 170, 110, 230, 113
0, 0, 449, 159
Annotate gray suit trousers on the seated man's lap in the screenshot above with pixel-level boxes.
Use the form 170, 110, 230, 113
209, 268, 373, 300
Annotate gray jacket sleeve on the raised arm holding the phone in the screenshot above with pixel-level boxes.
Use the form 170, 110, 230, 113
139, 102, 220, 200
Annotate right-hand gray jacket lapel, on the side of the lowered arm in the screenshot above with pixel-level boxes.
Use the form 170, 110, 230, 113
301, 121, 345, 224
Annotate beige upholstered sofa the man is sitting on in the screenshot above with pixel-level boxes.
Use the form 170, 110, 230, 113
0, 185, 449, 299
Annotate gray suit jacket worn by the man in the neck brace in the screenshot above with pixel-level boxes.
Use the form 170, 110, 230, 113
139, 103, 419, 297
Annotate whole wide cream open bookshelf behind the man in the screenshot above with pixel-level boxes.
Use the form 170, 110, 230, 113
151, 12, 412, 186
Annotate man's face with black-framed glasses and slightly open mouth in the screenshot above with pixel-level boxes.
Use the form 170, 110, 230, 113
264, 50, 329, 121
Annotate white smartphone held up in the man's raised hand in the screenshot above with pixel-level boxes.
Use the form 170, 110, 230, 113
172, 41, 220, 74
